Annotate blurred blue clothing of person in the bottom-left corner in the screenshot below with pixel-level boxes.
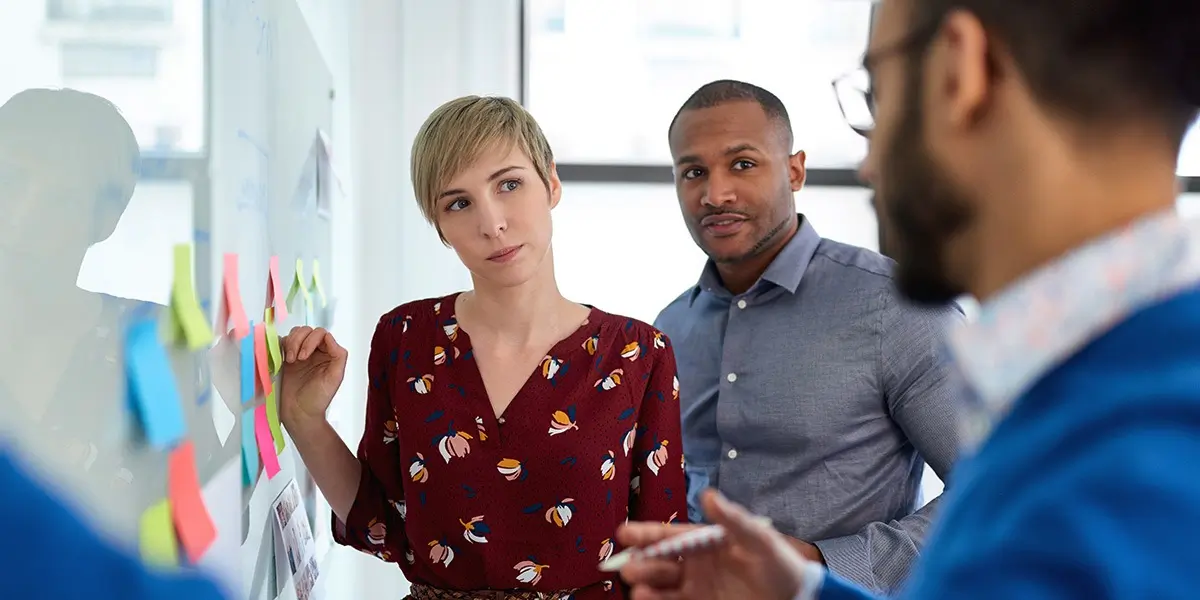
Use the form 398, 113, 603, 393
0, 449, 223, 600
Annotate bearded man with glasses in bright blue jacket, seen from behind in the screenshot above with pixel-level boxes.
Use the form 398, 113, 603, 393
619, 0, 1200, 600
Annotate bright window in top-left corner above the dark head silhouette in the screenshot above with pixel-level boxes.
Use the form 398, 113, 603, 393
0, 0, 205, 152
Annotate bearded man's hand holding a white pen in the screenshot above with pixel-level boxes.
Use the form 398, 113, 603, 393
610, 491, 821, 600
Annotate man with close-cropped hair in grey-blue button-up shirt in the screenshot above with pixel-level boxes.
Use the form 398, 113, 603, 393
655, 80, 961, 593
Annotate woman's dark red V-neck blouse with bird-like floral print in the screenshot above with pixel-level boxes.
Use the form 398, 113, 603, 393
334, 295, 688, 600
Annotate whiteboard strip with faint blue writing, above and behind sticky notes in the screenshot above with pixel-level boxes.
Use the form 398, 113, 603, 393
206, 0, 337, 599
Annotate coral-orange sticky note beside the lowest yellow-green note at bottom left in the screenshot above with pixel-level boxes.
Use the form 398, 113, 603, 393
167, 441, 216, 564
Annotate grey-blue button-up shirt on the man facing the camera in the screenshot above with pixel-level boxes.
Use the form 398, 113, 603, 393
655, 216, 961, 593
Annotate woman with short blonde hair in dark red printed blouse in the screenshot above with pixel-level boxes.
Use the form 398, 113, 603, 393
281, 96, 686, 600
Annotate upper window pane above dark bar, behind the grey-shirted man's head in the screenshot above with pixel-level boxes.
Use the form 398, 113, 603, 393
526, 0, 871, 168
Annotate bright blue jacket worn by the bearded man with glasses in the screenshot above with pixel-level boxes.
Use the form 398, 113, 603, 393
820, 290, 1200, 600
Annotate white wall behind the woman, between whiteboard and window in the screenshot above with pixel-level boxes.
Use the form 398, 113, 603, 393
300, 0, 521, 600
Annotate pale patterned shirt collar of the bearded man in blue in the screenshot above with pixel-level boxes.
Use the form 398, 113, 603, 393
947, 210, 1200, 445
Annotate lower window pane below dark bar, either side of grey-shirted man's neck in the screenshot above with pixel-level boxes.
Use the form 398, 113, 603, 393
554, 184, 878, 323
